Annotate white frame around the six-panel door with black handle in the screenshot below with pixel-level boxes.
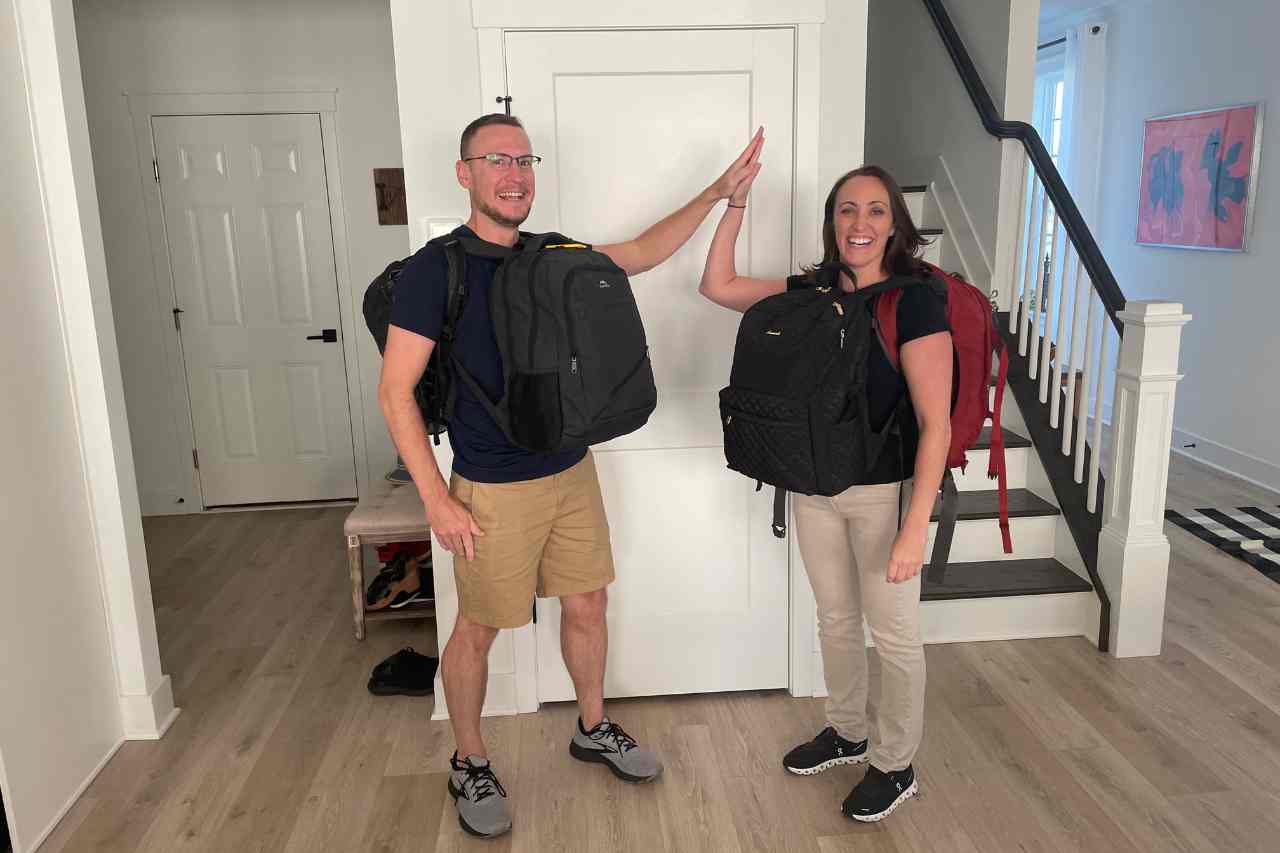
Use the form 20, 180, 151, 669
125, 90, 369, 514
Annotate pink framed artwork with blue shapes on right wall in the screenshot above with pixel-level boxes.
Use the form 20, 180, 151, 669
1138, 104, 1262, 252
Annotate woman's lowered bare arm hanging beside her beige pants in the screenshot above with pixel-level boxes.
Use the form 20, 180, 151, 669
887, 332, 952, 583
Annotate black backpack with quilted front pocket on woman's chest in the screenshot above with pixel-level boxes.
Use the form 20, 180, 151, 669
719, 279, 906, 538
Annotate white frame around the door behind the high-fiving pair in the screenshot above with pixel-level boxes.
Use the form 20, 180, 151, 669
476, 23, 824, 716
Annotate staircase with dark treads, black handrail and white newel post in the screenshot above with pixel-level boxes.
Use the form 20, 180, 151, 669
909, 0, 1190, 657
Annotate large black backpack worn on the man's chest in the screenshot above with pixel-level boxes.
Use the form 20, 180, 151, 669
453, 233, 658, 453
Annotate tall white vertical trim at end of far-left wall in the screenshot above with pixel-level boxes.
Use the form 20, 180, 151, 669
19, 0, 174, 736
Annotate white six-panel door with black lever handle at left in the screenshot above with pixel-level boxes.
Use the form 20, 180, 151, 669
152, 114, 356, 506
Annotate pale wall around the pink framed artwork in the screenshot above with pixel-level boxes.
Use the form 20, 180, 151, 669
1080, 0, 1280, 488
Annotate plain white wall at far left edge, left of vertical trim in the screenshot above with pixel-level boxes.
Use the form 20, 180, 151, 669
0, 4, 124, 850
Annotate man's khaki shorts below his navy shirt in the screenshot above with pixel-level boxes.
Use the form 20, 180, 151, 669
449, 452, 613, 628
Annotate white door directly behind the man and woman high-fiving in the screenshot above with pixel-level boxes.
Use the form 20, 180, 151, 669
506, 29, 795, 701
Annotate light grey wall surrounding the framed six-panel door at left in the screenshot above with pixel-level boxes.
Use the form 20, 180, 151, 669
76, 0, 404, 514
